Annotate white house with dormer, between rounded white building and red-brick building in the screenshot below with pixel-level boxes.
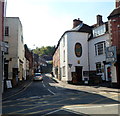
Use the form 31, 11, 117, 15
88, 15, 112, 82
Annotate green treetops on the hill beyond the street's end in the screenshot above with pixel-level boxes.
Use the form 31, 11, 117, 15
33, 46, 55, 56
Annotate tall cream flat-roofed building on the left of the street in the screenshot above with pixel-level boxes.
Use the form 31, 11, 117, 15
4, 17, 25, 86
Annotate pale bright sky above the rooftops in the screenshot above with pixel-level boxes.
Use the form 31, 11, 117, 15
6, 0, 115, 49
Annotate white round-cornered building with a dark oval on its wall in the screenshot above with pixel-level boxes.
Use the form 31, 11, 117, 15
53, 19, 91, 83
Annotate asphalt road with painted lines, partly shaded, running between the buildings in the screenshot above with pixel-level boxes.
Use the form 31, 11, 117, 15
2, 76, 120, 116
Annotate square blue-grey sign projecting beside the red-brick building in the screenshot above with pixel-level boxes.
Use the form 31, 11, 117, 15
106, 46, 117, 63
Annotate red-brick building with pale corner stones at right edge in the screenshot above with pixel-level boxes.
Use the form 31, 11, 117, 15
108, 0, 120, 87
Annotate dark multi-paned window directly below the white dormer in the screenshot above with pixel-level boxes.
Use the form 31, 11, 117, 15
95, 42, 105, 56
